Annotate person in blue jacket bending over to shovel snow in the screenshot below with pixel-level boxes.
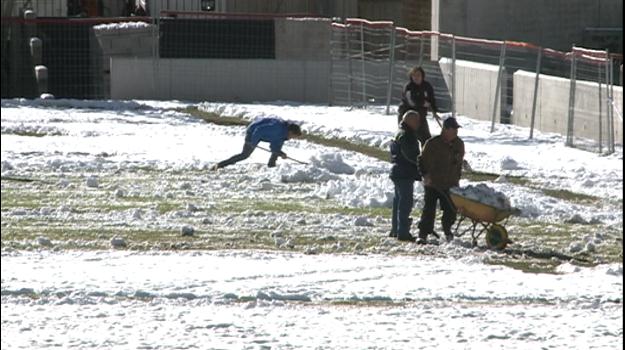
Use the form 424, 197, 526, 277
212, 118, 302, 170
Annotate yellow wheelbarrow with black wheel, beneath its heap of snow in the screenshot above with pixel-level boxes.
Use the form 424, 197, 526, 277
449, 192, 519, 249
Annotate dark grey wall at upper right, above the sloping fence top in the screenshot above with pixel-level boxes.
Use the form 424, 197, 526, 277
432, 0, 623, 52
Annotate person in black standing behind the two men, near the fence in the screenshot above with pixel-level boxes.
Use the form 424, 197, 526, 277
397, 67, 438, 145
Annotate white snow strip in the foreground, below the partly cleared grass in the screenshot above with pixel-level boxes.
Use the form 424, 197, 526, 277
2, 251, 623, 349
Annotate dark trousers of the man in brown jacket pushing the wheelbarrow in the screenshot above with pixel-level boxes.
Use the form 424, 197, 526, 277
419, 186, 456, 238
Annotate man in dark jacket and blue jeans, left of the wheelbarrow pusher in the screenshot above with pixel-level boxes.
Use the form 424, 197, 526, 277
390, 110, 422, 242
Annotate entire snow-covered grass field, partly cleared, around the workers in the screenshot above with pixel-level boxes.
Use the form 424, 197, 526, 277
1, 100, 623, 349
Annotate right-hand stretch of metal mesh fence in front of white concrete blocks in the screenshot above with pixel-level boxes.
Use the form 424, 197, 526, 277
331, 19, 623, 153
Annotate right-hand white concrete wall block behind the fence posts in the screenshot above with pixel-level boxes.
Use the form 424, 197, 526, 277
512, 71, 623, 145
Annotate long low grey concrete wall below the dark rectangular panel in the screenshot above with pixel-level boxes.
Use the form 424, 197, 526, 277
111, 57, 330, 103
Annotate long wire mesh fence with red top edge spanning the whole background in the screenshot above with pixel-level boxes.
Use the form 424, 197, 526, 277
2, 0, 623, 153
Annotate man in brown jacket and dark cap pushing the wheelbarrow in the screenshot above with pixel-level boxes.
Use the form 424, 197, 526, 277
417, 118, 464, 244
